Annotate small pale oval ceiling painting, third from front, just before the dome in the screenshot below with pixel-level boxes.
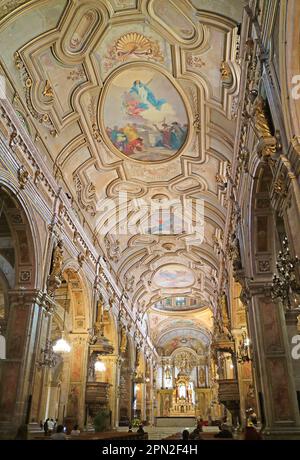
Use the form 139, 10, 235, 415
153, 264, 195, 289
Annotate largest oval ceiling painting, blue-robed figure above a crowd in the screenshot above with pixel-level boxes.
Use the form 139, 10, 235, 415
101, 65, 188, 162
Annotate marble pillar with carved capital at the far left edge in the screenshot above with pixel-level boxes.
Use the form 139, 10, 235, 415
0, 290, 41, 434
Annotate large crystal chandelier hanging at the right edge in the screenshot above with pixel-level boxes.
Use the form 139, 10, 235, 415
271, 237, 300, 309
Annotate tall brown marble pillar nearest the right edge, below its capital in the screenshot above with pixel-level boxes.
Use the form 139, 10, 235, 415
249, 290, 300, 439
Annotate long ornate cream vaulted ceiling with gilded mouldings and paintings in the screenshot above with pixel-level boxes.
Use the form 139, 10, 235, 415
0, 0, 243, 356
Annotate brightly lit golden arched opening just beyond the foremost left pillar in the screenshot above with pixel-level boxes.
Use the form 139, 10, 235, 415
30, 268, 89, 429
